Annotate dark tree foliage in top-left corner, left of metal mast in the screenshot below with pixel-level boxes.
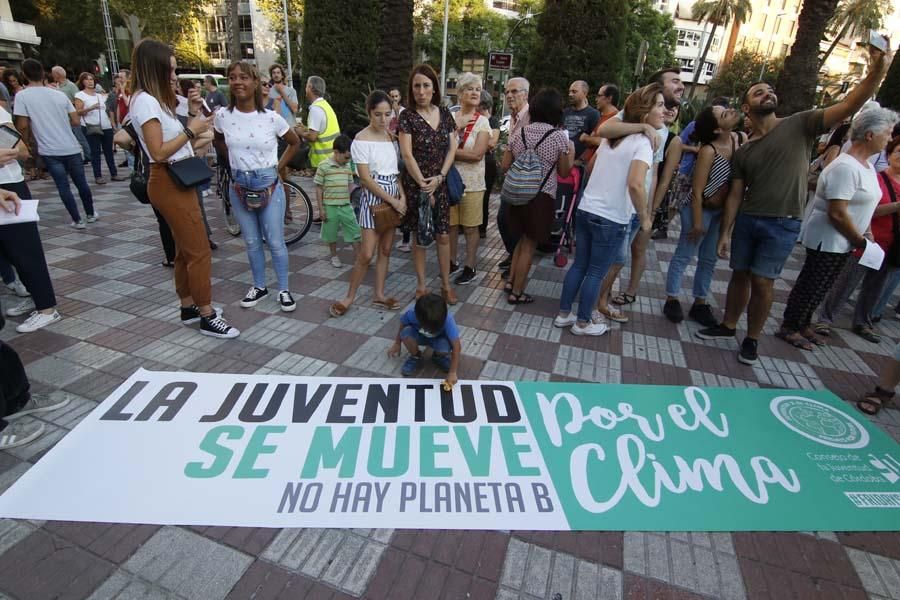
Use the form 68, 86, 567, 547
10, 0, 106, 76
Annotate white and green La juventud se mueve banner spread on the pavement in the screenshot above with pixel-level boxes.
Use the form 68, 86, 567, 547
0, 370, 900, 531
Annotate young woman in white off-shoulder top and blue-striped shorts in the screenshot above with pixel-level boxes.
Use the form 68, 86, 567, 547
328, 90, 406, 317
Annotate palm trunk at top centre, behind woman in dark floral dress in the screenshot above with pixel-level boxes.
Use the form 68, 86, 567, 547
375, 0, 413, 94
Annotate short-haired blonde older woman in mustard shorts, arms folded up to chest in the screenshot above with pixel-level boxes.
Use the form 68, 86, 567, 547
450, 73, 491, 285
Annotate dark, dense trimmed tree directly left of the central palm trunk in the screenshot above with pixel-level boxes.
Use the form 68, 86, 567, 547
295, 0, 381, 131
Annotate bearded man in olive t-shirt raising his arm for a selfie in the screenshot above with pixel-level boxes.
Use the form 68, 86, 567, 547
697, 47, 891, 365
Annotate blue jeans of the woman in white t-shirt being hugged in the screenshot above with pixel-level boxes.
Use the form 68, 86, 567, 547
559, 210, 629, 322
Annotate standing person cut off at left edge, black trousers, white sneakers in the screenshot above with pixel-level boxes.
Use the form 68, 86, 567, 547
0, 108, 61, 333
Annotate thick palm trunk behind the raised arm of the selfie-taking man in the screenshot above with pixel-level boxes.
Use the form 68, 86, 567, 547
775, 0, 838, 116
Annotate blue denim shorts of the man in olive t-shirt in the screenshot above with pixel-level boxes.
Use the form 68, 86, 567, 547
730, 213, 800, 279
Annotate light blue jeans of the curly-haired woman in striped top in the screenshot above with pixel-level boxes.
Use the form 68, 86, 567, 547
666, 204, 722, 299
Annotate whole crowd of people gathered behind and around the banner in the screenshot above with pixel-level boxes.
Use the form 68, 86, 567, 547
0, 39, 900, 446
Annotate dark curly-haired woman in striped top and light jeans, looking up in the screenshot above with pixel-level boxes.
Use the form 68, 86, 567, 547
663, 106, 741, 327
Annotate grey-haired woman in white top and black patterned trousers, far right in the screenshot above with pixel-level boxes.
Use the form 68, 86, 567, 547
776, 108, 898, 350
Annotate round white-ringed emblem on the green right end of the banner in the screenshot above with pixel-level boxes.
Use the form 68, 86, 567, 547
769, 396, 869, 449
